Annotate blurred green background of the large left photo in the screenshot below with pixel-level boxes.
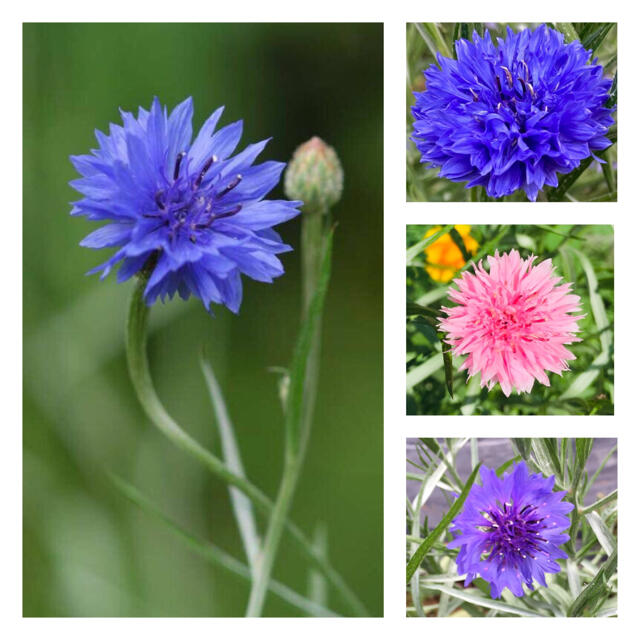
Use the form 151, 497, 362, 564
23, 24, 382, 616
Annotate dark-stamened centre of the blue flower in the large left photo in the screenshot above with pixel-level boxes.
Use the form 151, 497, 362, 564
143, 151, 242, 244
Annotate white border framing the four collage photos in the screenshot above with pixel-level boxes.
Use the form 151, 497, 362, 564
0, 0, 640, 640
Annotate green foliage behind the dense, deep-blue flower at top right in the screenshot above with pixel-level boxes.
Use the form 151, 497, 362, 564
407, 22, 617, 202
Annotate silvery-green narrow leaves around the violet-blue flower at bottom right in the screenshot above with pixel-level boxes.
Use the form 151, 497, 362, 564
407, 438, 618, 617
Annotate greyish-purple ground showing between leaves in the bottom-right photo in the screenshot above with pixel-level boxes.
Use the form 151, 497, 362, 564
407, 438, 618, 523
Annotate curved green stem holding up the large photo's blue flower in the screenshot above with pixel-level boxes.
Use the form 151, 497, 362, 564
126, 275, 368, 616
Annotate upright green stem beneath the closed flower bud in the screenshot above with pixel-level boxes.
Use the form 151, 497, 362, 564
246, 210, 328, 617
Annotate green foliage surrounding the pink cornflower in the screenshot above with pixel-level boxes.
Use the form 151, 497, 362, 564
406, 225, 614, 416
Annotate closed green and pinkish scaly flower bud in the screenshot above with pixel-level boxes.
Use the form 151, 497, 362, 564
284, 136, 343, 213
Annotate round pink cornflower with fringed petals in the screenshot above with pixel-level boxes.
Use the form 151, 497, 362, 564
440, 249, 584, 396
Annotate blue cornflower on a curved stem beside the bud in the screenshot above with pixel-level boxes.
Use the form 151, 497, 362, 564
71, 98, 302, 313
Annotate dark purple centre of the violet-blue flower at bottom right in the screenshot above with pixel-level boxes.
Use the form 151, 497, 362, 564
477, 502, 549, 564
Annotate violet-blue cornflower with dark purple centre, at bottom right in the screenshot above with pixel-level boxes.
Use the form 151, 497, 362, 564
448, 462, 573, 598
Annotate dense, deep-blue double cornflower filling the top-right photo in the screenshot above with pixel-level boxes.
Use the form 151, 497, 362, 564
411, 25, 614, 201
